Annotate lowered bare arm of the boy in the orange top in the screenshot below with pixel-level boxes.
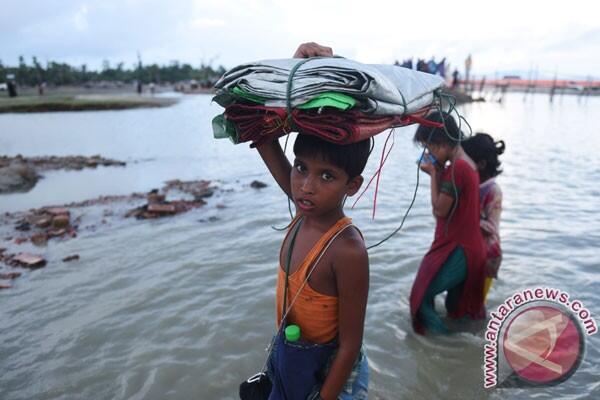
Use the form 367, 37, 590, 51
320, 231, 369, 400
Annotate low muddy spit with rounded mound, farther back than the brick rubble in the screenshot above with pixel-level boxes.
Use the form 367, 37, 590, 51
0, 155, 126, 194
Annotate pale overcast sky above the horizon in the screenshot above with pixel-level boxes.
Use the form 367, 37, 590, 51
0, 0, 600, 79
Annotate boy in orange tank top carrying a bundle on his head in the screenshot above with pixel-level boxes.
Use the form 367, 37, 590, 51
257, 43, 370, 400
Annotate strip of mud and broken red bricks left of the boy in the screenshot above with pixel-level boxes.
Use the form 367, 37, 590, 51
0, 180, 265, 289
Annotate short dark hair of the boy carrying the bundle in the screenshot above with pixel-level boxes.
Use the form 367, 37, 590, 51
294, 134, 371, 179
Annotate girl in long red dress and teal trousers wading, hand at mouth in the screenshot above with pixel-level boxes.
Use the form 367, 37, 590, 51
410, 112, 486, 334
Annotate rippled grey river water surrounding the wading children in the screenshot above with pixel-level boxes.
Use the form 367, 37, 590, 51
0, 94, 600, 399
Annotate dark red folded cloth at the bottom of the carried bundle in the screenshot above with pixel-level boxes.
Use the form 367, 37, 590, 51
225, 104, 425, 145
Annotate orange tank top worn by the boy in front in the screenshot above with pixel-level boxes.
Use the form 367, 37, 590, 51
276, 217, 352, 343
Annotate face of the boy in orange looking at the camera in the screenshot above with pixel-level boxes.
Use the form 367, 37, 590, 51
291, 156, 363, 216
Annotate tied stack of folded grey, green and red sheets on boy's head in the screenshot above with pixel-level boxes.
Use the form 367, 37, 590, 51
213, 58, 444, 145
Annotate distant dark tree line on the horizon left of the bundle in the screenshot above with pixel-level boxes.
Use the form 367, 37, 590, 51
0, 56, 225, 87
